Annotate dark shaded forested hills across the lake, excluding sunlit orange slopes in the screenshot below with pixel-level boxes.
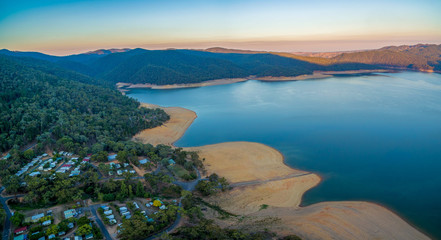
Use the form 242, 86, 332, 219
0, 49, 378, 85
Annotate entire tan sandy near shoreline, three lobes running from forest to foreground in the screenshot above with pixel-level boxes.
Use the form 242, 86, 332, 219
134, 101, 429, 240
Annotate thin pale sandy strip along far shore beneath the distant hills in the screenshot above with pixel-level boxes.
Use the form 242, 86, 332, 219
116, 69, 390, 93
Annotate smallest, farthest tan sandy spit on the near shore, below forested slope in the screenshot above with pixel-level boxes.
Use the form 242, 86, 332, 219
132, 103, 196, 146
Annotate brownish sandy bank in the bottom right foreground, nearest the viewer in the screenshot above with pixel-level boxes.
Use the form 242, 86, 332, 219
250, 201, 429, 240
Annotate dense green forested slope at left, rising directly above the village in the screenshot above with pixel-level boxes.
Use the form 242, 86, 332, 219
0, 55, 168, 152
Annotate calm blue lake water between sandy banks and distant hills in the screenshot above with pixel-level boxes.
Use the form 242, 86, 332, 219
128, 72, 441, 239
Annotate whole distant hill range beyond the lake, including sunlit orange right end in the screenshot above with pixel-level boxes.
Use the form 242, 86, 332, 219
0, 44, 441, 85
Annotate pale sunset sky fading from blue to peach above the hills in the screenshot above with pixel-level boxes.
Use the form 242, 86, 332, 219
0, 0, 441, 55
